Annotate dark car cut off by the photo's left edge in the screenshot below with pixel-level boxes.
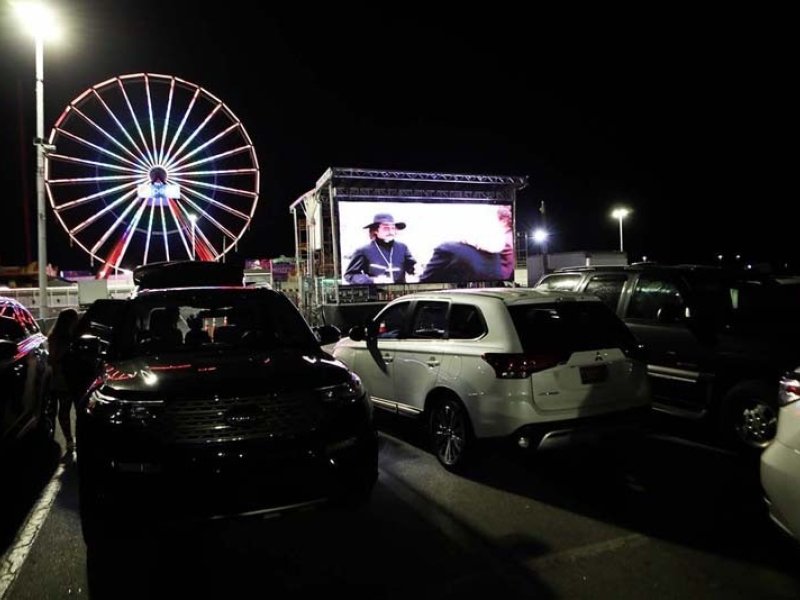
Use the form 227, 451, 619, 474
0, 297, 55, 450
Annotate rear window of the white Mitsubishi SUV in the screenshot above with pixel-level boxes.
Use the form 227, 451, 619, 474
508, 302, 636, 353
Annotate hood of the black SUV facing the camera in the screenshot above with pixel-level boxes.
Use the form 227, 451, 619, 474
103, 351, 350, 396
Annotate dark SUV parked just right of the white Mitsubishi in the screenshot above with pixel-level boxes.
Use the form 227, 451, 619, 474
535, 263, 800, 449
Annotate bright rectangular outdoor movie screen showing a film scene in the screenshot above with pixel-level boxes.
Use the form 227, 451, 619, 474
338, 200, 514, 285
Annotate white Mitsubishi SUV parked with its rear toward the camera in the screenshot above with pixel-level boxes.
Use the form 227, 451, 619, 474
333, 288, 650, 470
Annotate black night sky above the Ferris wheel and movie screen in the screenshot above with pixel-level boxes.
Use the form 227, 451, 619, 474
0, 0, 800, 268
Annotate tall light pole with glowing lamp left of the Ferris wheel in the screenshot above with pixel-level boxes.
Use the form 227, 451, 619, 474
14, 2, 55, 317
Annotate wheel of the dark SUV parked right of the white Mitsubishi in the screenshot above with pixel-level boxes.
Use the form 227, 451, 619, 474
722, 381, 778, 450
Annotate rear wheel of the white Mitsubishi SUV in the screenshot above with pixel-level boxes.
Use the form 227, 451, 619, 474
428, 398, 475, 473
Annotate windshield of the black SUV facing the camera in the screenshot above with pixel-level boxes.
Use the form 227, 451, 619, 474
117, 288, 319, 357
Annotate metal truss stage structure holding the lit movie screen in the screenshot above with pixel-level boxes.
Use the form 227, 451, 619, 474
290, 167, 528, 327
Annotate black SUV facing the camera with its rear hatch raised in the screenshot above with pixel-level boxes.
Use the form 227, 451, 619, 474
71, 264, 378, 545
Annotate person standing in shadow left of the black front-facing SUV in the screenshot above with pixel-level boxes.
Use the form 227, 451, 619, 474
47, 308, 78, 454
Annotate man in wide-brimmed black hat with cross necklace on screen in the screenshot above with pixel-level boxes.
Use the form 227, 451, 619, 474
344, 213, 417, 284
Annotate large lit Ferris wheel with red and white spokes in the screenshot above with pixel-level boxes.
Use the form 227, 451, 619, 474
45, 73, 259, 269
